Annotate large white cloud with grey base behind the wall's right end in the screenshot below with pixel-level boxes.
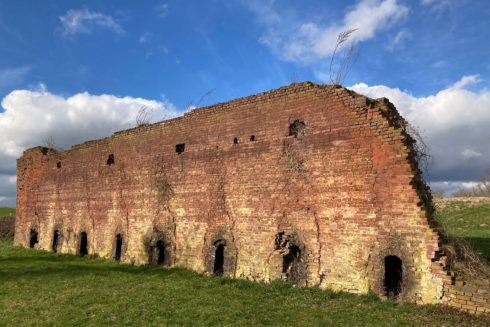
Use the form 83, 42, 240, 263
351, 75, 490, 195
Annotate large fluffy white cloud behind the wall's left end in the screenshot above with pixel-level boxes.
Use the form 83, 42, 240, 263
0, 85, 178, 205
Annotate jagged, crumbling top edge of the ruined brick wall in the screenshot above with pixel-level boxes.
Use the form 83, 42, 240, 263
24, 81, 403, 154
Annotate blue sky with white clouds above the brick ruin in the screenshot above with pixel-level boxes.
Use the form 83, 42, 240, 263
0, 0, 490, 206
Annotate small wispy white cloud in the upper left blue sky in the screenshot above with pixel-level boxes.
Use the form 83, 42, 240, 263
59, 9, 124, 35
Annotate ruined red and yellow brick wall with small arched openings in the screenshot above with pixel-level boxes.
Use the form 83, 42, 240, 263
15, 82, 443, 302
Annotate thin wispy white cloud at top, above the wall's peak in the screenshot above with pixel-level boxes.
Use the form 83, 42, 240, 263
255, 0, 408, 63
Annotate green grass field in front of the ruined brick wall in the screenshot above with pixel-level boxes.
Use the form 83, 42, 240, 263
0, 240, 490, 327
